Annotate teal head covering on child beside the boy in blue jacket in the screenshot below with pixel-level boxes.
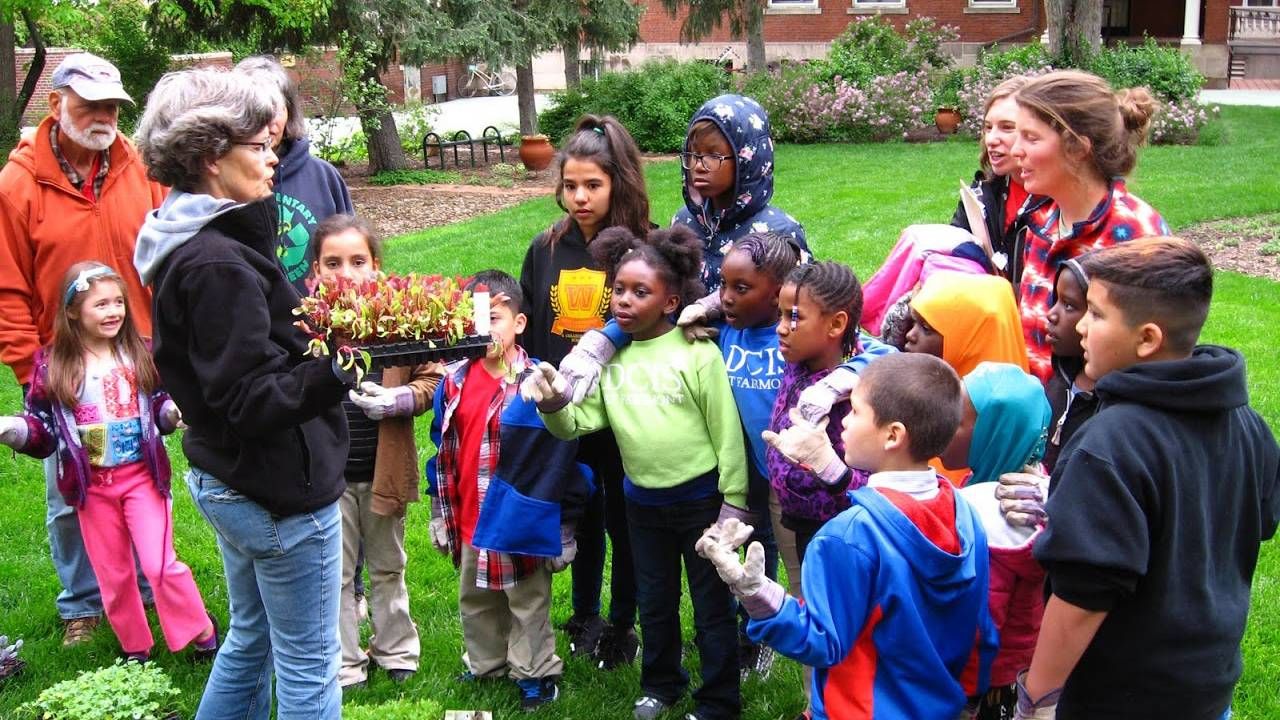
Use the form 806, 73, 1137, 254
964, 363, 1053, 483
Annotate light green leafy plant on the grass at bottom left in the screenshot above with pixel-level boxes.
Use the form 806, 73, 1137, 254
22, 660, 178, 720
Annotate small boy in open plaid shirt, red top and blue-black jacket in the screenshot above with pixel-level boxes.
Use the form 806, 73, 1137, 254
426, 270, 590, 710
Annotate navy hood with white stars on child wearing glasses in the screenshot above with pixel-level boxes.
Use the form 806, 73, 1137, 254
682, 95, 773, 234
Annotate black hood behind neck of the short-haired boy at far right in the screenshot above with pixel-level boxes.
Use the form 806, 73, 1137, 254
1094, 345, 1249, 413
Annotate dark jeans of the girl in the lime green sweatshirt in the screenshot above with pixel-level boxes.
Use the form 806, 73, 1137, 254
627, 495, 742, 720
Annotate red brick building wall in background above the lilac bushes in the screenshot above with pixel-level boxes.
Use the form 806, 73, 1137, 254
640, 0, 1044, 42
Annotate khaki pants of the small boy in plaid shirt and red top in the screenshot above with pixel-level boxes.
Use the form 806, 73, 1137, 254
458, 543, 563, 680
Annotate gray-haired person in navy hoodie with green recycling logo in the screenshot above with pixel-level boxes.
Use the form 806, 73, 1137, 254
236, 55, 355, 295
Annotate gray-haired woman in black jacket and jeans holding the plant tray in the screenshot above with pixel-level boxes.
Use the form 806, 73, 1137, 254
134, 70, 353, 720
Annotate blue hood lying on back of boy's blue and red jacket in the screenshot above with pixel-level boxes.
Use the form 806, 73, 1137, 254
849, 484, 987, 603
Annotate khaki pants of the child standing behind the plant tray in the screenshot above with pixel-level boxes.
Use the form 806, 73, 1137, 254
338, 483, 421, 685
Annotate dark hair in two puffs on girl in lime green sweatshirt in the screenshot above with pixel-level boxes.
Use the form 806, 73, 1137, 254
588, 225, 705, 306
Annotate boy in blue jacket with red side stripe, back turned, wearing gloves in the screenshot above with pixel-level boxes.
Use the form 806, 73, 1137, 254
698, 354, 997, 720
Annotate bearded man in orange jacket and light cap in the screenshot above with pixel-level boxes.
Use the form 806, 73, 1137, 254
0, 53, 165, 644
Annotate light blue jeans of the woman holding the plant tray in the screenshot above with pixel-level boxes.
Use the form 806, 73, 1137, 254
187, 468, 342, 720
